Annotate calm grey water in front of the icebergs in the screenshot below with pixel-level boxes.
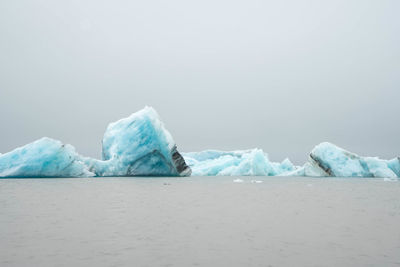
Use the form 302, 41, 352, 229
0, 177, 400, 267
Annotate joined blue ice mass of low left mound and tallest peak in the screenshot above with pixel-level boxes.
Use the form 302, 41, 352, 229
0, 107, 191, 177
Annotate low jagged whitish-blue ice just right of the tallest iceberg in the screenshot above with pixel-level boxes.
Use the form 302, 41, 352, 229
183, 149, 295, 176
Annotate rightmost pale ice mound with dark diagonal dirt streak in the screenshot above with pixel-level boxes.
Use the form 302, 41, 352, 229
284, 142, 400, 178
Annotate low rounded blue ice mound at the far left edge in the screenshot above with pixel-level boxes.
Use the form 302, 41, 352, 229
0, 137, 94, 177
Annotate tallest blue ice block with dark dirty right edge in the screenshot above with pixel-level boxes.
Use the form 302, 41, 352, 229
84, 107, 191, 176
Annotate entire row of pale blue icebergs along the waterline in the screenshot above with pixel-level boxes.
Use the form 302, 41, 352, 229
0, 107, 400, 178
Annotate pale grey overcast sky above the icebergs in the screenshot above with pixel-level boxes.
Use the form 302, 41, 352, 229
0, 0, 400, 164
